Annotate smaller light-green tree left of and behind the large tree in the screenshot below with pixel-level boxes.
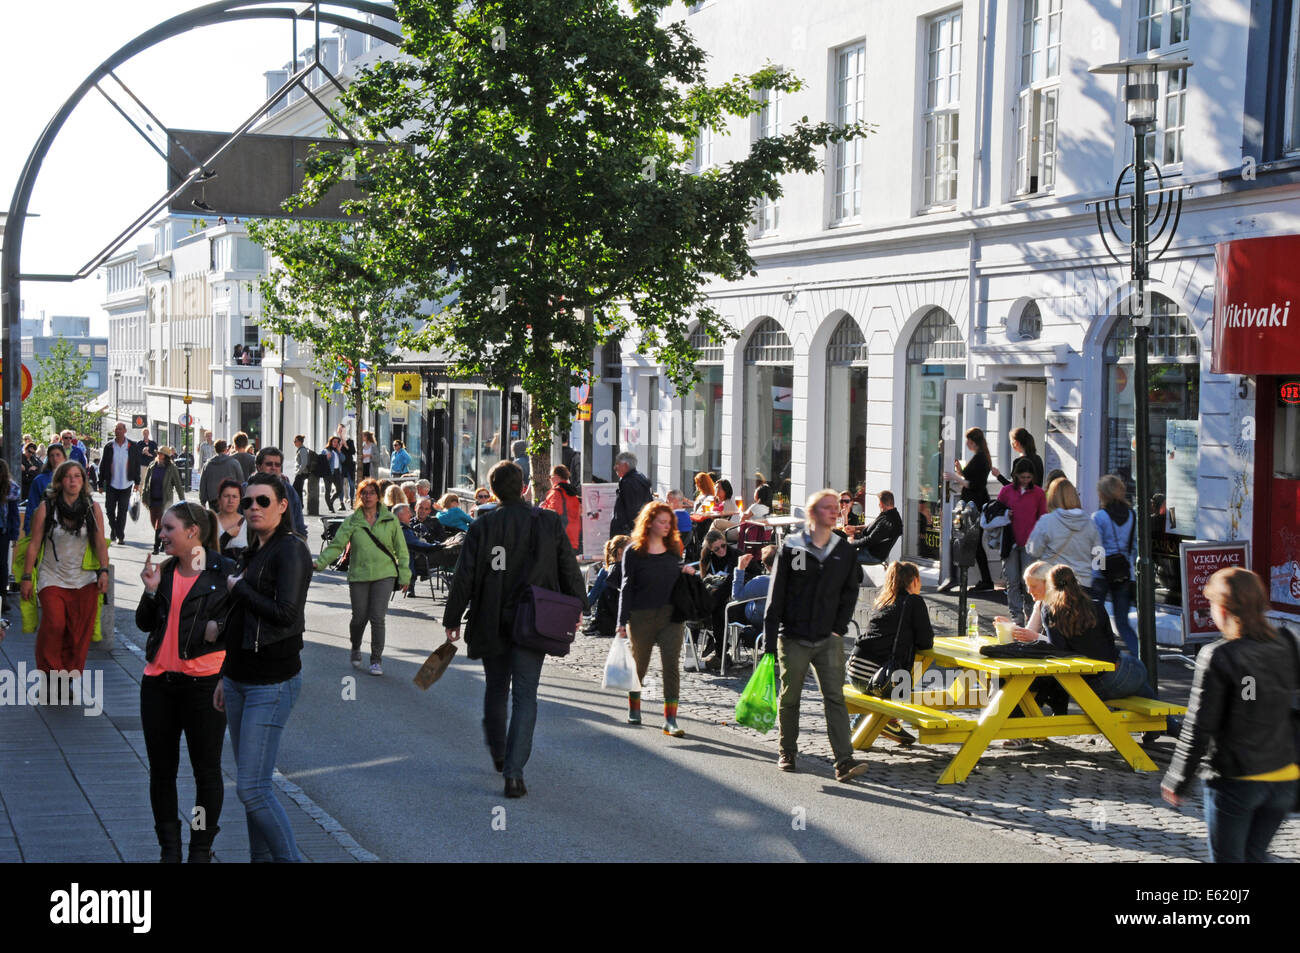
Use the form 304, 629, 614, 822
248, 217, 420, 428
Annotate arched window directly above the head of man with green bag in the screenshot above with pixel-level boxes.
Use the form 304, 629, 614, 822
823, 315, 867, 494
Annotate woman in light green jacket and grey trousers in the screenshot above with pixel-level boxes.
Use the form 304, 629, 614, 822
315, 480, 411, 675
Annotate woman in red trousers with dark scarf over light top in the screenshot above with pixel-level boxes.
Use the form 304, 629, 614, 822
20, 460, 108, 676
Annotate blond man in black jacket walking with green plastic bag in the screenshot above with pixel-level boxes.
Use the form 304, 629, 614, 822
763, 490, 867, 781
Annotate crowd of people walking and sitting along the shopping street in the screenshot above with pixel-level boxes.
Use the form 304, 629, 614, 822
0, 424, 1300, 862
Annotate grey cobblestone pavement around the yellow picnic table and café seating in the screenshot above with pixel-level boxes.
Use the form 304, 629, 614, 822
550, 590, 1300, 862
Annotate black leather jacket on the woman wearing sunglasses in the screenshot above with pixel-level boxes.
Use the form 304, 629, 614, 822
230, 520, 312, 651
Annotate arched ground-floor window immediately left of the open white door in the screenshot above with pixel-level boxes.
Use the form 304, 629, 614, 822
904, 308, 966, 559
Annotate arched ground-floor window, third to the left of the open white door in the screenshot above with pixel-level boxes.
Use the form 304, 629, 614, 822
743, 317, 794, 510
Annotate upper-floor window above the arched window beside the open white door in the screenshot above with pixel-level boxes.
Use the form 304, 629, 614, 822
922, 10, 962, 205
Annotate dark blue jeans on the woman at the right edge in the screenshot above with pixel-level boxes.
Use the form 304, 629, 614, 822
1205, 777, 1300, 863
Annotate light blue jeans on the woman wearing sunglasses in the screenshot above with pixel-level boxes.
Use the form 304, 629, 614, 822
222, 672, 303, 863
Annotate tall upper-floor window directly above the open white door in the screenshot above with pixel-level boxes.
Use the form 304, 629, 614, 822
1015, 0, 1063, 195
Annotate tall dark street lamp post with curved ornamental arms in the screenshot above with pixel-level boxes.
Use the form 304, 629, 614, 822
1089, 57, 1192, 692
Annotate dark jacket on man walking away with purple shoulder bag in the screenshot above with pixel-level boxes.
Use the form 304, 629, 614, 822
442, 501, 588, 658
